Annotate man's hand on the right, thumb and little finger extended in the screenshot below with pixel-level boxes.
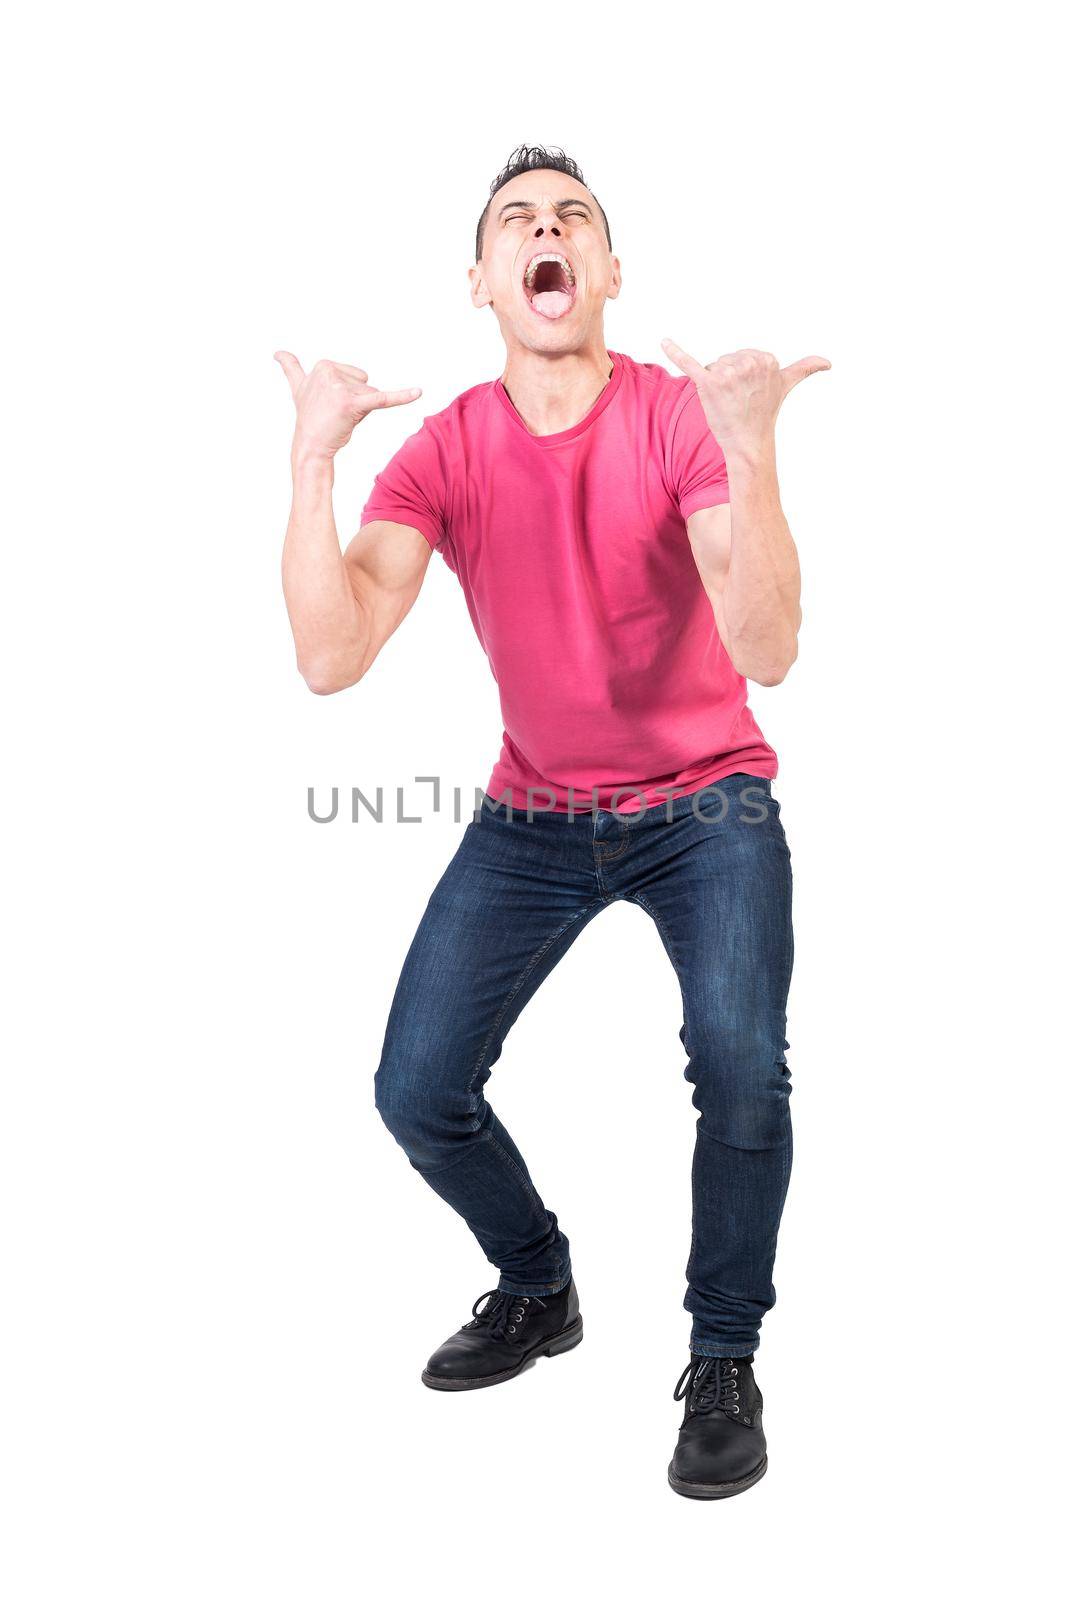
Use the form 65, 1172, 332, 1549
660, 339, 831, 456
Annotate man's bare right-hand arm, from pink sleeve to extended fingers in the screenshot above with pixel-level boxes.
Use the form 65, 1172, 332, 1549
662, 339, 831, 685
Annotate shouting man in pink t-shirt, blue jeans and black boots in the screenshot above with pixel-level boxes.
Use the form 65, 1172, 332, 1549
277, 146, 830, 1499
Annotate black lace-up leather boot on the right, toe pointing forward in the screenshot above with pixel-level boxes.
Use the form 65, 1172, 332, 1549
668, 1355, 767, 1499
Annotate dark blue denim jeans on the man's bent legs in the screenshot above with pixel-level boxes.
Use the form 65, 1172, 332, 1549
374, 773, 793, 1355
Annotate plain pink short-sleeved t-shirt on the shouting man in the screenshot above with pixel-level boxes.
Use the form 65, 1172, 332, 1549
360, 350, 779, 813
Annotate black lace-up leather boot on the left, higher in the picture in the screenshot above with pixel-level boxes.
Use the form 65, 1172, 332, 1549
422, 1280, 582, 1389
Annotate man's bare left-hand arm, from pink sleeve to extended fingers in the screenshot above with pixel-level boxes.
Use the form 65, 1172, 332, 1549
277, 350, 430, 694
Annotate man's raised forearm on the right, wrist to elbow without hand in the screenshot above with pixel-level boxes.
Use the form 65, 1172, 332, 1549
723, 442, 801, 683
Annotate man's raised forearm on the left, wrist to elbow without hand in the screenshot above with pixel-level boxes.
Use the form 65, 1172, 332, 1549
281, 442, 363, 693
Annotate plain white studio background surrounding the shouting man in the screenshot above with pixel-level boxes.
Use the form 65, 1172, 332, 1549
0, 3, 1065, 1600
